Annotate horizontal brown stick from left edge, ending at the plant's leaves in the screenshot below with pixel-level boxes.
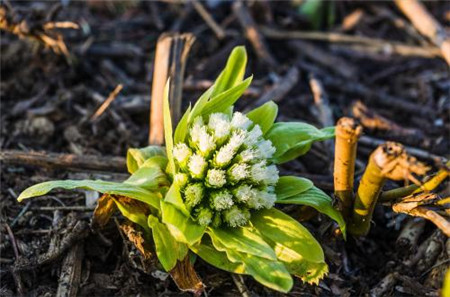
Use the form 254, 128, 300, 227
0, 150, 127, 172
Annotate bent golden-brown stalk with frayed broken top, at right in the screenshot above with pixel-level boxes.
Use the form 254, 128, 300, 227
349, 142, 429, 236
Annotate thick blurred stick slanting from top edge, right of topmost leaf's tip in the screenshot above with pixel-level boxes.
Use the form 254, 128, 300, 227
233, 0, 278, 67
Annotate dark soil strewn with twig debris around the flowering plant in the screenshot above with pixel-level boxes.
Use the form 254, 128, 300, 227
0, 0, 450, 296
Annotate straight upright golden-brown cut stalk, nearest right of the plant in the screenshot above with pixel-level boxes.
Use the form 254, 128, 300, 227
333, 118, 362, 218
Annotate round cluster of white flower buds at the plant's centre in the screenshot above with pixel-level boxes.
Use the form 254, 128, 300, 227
173, 112, 278, 227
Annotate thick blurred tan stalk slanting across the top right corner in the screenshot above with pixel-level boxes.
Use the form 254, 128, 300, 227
394, 0, 450, 66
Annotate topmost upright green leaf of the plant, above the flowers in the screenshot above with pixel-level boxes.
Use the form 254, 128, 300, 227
211, 46, 247, 97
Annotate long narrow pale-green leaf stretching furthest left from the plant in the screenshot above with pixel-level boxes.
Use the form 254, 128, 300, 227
17, 180, 161, 209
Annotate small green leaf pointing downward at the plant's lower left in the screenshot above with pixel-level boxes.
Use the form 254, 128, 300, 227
148, 215, 188, 271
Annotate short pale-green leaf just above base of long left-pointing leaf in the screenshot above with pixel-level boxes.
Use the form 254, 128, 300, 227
123, 163, 170, 191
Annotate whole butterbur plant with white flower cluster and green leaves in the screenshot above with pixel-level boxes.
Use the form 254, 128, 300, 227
19, 47, 345, 292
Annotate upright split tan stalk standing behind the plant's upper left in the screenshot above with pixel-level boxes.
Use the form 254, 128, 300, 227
149, 33, 195, 145
